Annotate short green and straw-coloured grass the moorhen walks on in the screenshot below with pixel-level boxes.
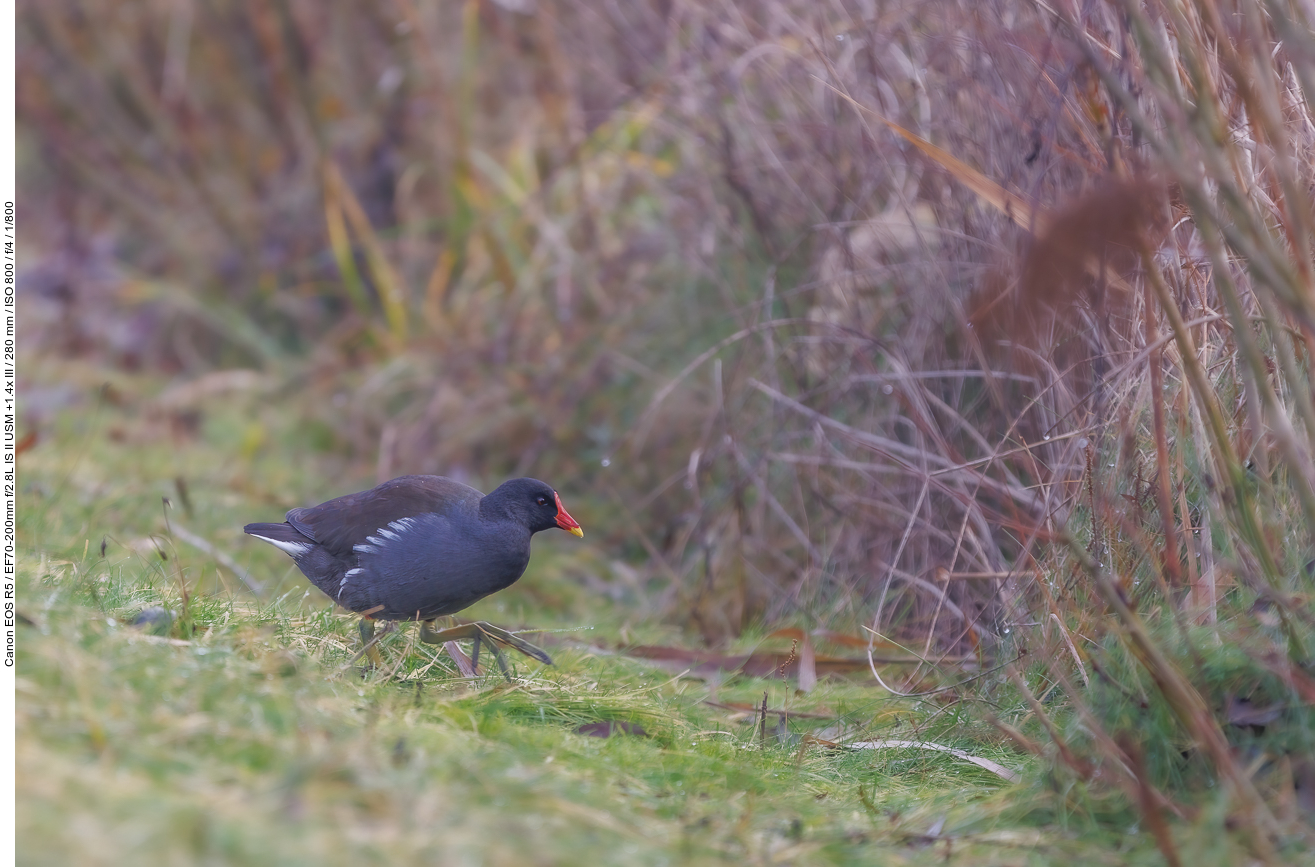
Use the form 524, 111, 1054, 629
17, 364, 1188, 864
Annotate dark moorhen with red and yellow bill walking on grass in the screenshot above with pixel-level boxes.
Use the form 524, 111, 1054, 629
243, 475, 584, 679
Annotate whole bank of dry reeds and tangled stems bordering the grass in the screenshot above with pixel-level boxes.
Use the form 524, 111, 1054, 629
18, 0, 1315, 863
